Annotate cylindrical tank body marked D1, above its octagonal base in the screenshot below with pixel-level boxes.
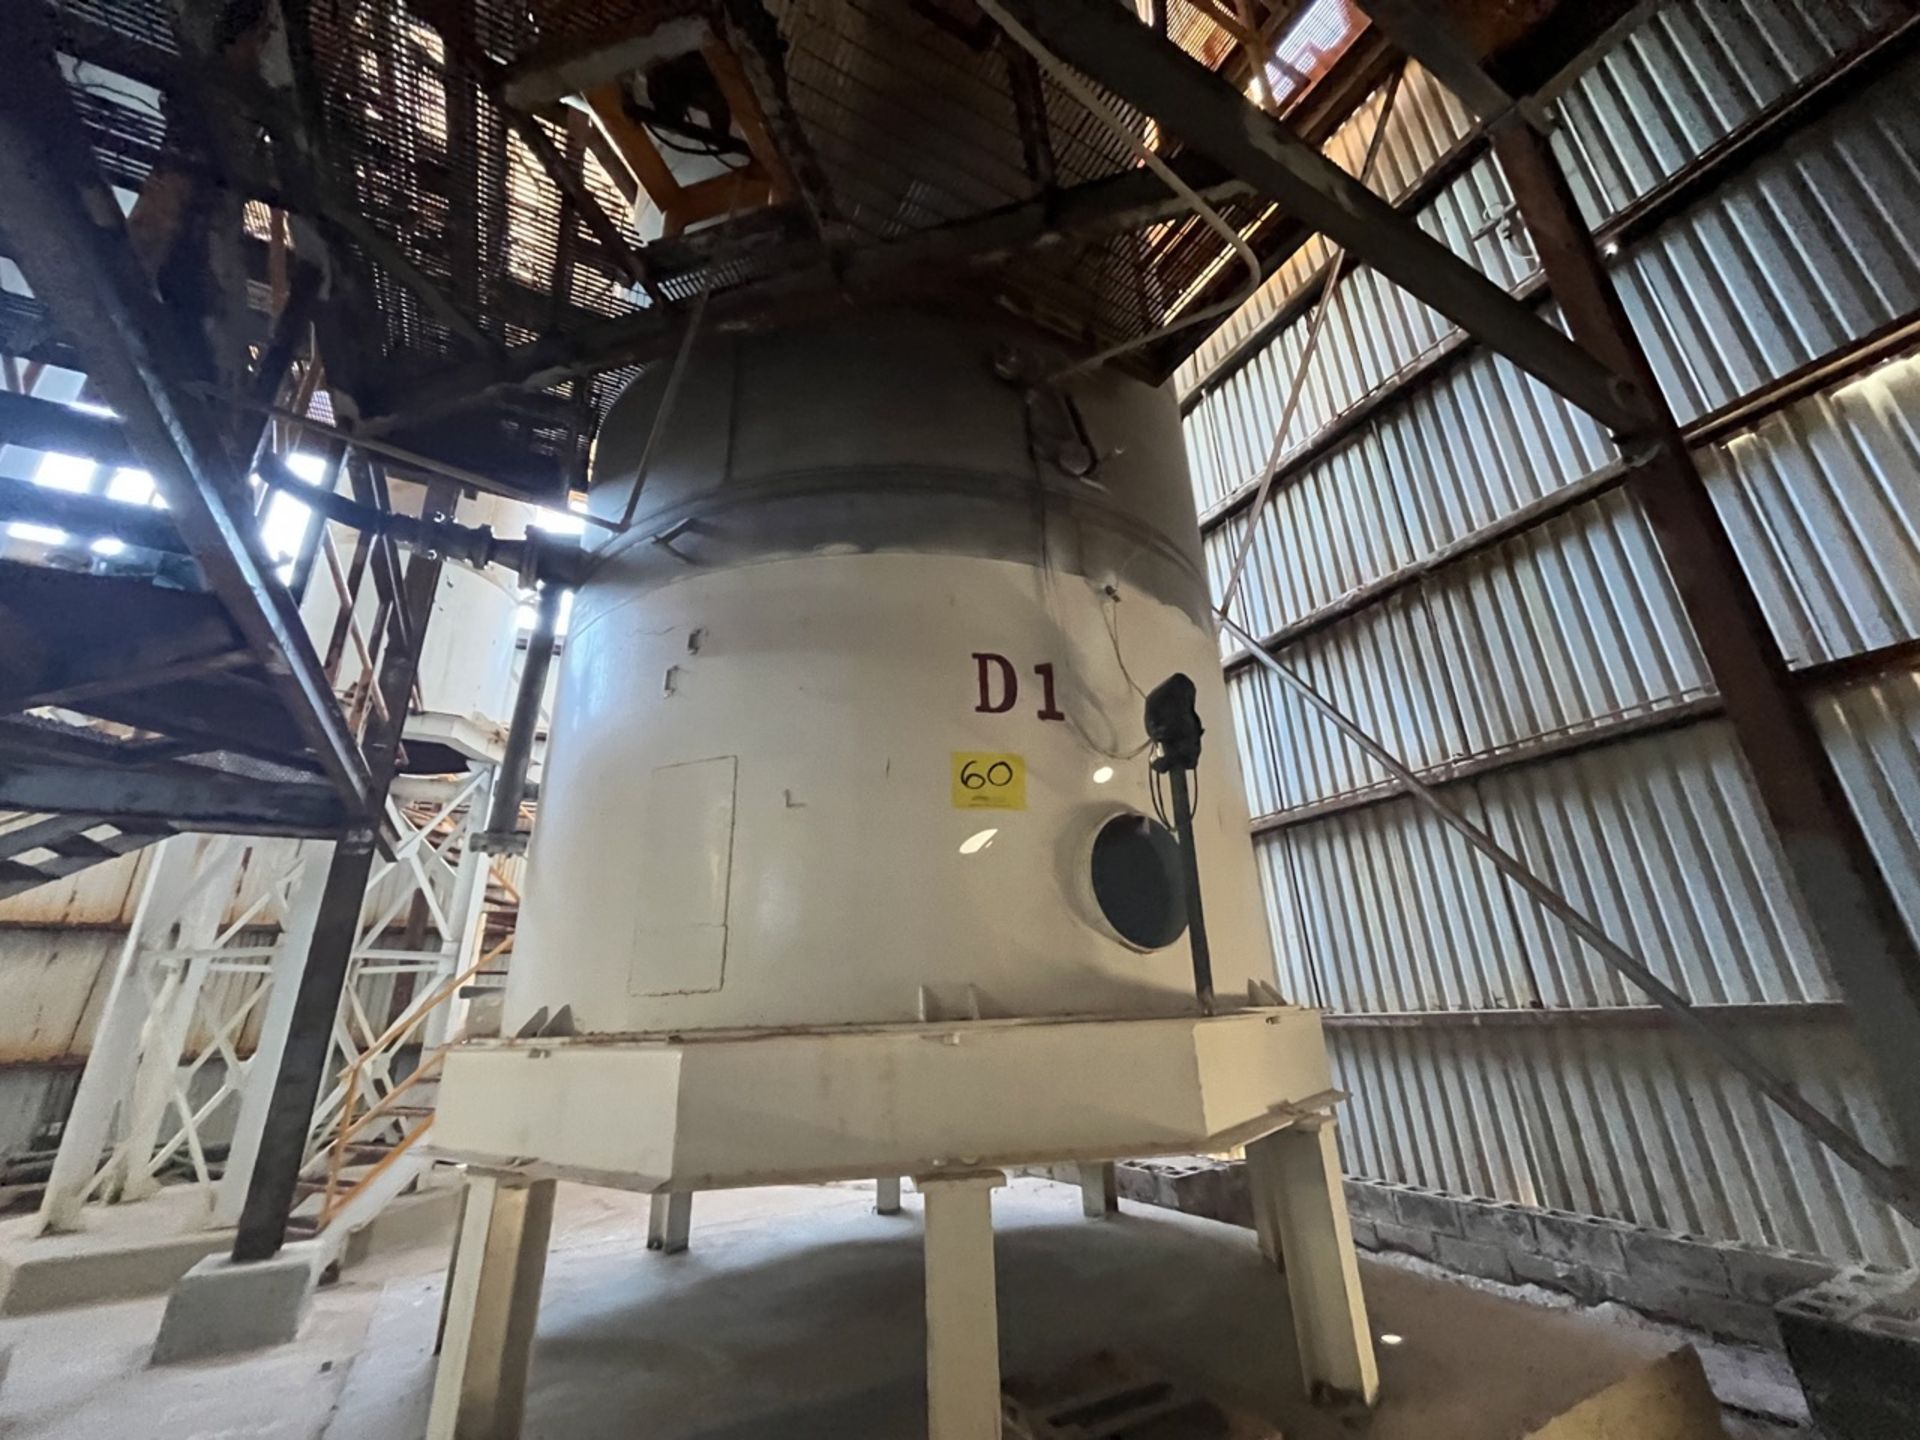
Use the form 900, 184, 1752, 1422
507, 313, 1273, 1033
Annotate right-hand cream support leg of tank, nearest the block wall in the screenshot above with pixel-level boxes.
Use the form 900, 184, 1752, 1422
1246, 1116, 1380, 1405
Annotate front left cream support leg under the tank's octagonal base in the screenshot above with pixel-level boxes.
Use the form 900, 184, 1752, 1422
426, 1173, 555, 1440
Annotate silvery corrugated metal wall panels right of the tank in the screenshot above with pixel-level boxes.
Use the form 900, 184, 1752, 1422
1179, 0, 1920, 1263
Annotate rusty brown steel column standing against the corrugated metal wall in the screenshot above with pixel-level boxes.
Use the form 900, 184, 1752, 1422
1494, 123, 1920, 1167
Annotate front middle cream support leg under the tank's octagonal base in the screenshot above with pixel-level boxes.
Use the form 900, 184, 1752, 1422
916, 1171, 1006, 1440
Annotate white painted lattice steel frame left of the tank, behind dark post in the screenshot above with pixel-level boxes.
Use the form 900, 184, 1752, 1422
40, 770, 490, 1231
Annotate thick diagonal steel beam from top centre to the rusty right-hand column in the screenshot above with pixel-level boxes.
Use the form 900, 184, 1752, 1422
1004, 0, 1649, 434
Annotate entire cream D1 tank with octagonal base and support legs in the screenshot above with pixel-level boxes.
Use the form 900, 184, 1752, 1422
430, 313, 1379, 1440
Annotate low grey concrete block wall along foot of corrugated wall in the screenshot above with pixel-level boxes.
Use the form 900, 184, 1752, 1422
1119, 1156, 1837, 1350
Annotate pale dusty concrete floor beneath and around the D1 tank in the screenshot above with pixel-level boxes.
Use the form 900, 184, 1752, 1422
0, 1181, 1778, 1440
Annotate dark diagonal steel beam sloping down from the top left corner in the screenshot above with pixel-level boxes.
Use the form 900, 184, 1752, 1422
0, 6, 372, 816
